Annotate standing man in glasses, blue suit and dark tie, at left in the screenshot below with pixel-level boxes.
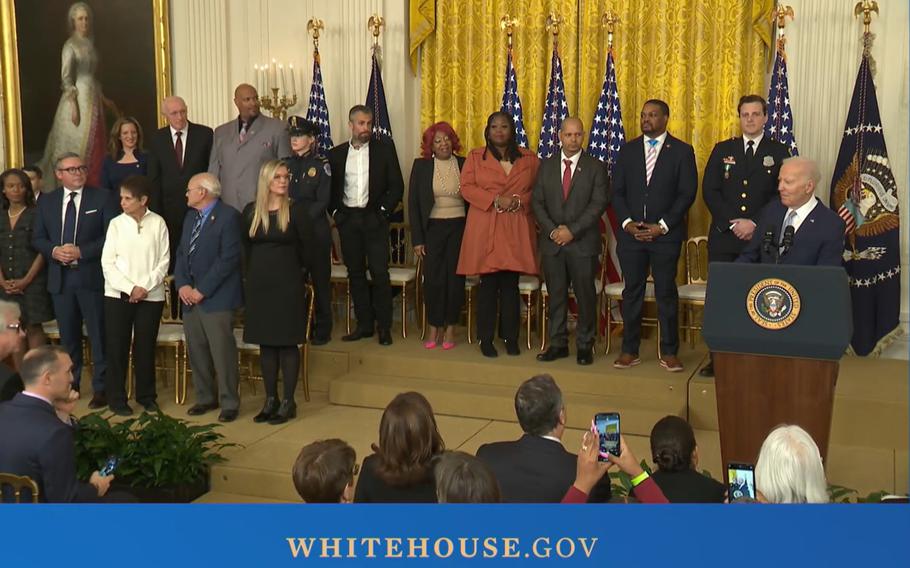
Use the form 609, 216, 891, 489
32, 153, 120, 408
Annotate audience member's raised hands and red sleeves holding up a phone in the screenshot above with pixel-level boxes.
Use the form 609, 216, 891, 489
562, 432, 669, 504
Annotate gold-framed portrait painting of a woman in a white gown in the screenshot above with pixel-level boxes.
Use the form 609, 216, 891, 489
0, 0, 170, 185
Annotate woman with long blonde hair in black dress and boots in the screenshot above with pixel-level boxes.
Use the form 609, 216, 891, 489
241, 160, 314, 424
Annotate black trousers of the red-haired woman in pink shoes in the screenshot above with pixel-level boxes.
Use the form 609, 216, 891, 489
423, 217, 464, 327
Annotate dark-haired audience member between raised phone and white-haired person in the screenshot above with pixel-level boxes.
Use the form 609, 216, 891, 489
651, 416, 726, 503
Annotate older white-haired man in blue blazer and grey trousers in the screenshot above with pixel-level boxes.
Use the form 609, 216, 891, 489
174, 173, 243, 422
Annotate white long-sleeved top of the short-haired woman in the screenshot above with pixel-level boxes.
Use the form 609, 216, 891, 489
101, 210, 171, 302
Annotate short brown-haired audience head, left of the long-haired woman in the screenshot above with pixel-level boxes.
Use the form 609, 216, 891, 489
291, 438, 357, 503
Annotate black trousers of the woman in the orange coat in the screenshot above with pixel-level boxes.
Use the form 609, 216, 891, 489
477, 271, 521, 342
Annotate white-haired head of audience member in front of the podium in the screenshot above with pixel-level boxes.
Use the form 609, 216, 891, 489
755, 425, 829, 503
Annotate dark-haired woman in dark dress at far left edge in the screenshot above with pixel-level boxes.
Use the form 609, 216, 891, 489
0, 169, 54, 360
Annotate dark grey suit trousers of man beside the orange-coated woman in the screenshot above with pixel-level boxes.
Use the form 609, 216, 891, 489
541, 251, 597, 349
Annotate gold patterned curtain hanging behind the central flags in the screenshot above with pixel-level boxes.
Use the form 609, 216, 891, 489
421, 0, 773, 235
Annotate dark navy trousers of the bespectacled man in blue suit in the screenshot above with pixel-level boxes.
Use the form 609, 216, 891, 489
51, 268, 107, 393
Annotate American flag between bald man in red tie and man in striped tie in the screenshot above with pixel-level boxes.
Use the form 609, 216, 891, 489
588, 48, 626, 288
